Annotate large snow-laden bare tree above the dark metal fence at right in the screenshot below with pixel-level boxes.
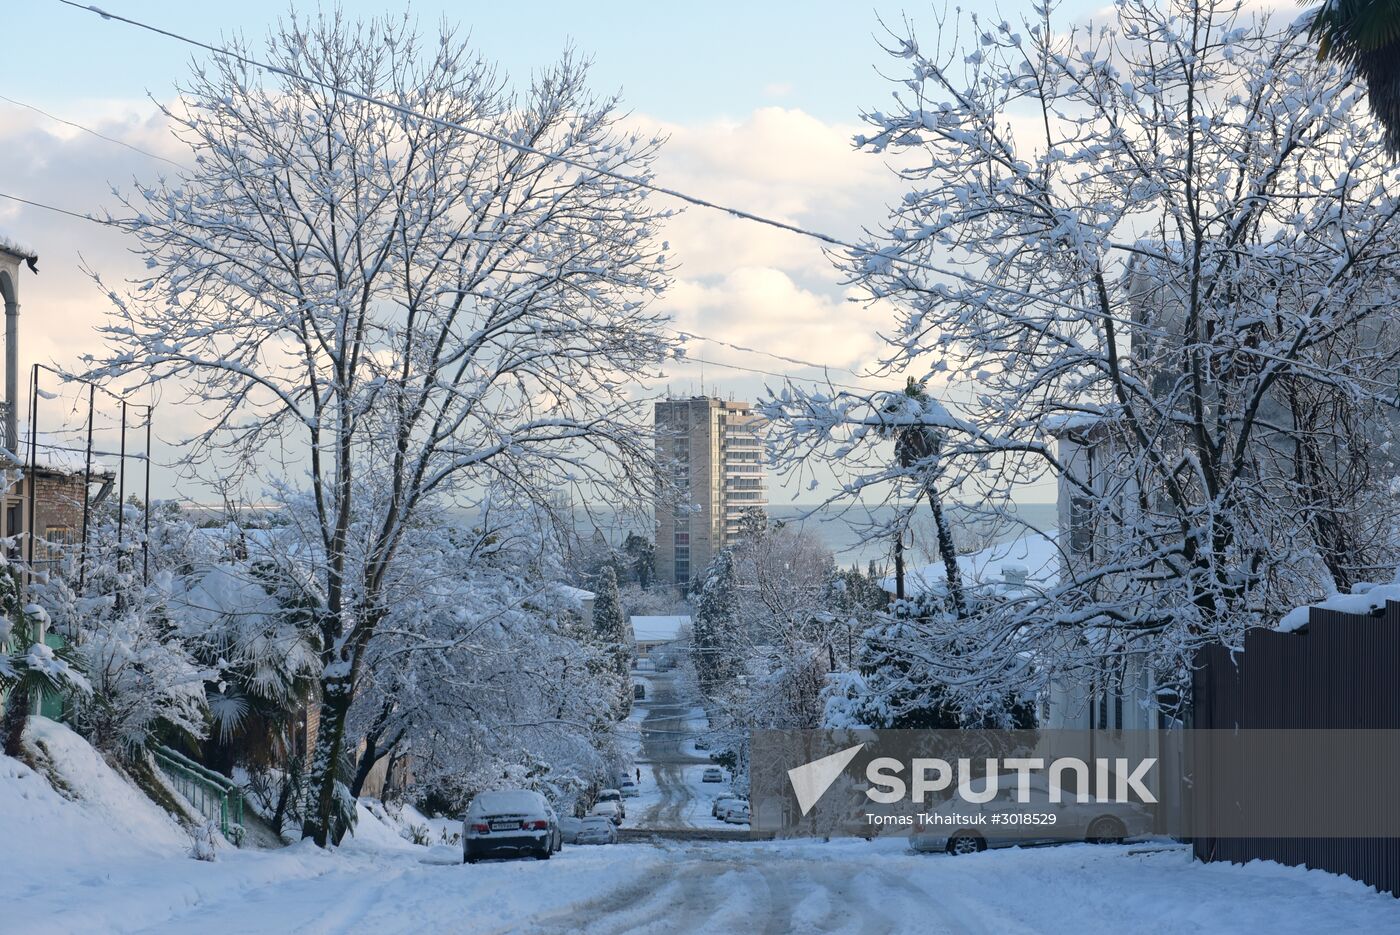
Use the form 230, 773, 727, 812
764, 0, 1400, 708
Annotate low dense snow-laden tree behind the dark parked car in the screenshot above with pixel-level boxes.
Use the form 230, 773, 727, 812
338, 508, 617, 806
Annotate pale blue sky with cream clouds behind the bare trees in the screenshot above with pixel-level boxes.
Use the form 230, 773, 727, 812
0, 0, 1114, 502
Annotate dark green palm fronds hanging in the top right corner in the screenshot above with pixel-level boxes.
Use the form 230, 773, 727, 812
1308, 0, 1400, 155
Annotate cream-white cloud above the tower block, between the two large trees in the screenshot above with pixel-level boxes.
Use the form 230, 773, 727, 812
640, 108, 897, 384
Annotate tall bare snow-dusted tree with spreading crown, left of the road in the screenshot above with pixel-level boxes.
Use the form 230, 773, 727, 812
94, 14, 671, 844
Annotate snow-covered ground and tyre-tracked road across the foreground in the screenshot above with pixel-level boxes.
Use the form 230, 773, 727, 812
0, 724, 1400, 935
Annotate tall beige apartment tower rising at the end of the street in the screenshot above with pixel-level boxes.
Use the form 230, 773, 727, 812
655, 396, 769, 585
